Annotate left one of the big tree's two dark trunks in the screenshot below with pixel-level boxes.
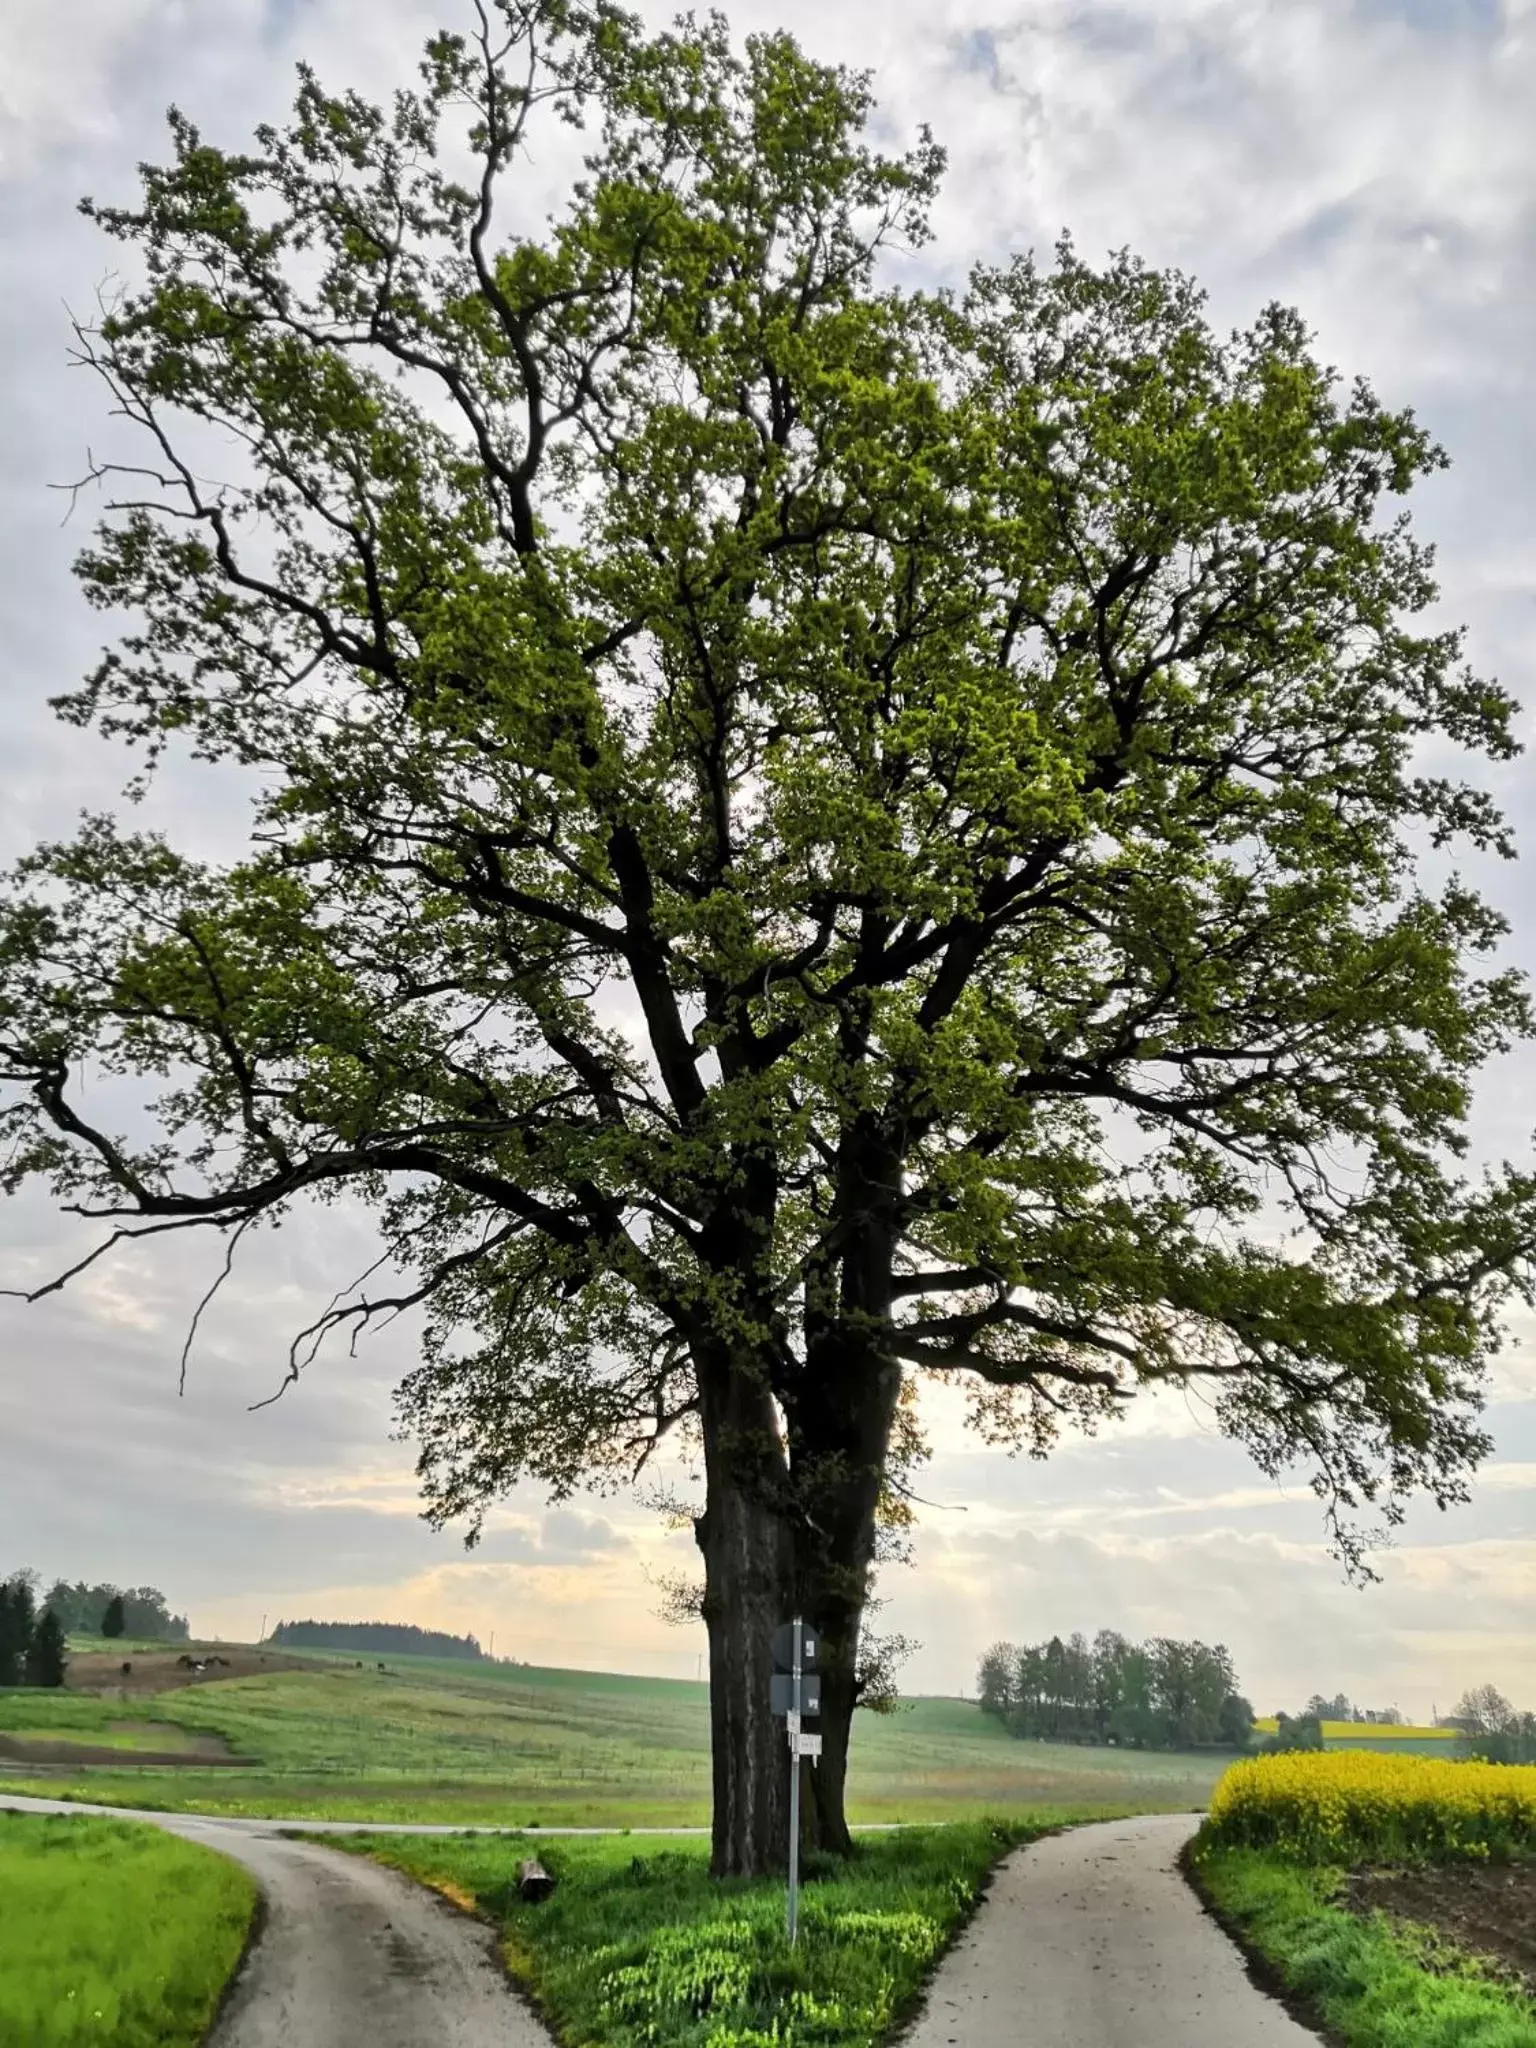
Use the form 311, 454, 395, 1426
696, 1356, 795, 1878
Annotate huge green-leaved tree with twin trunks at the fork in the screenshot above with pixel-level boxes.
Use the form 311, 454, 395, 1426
0, 0, 1532, 1872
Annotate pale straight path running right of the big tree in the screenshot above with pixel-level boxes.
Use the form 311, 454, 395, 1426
903, 1815, 1317, 2048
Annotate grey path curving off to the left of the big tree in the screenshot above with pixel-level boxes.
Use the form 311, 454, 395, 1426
0, 1798, 549, 2048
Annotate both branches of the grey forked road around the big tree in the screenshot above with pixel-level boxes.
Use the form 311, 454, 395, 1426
0, 1796, 1317, 2048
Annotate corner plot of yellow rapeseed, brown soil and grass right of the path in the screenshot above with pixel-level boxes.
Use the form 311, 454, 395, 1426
1190, 1753, 1536, 2048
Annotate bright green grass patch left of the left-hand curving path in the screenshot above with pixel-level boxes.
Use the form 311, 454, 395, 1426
0, 1812, 256, 2048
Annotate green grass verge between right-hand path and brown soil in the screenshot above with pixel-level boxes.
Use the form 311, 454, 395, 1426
1192, 1841, 1536, 2048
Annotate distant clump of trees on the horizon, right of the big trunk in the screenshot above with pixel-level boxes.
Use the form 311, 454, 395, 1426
979, 1628, 1253, 1749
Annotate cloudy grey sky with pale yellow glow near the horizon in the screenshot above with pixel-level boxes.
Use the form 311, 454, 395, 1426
0, 0, 1536, 1716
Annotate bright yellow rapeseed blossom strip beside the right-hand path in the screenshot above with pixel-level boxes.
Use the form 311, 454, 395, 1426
1206, 1749, 1536, 1864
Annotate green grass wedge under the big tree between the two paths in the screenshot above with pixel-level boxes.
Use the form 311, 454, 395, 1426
348, 1812, 1073, 2048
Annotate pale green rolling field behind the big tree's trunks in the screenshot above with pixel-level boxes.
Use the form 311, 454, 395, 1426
0, 1657, 1223, 1827
